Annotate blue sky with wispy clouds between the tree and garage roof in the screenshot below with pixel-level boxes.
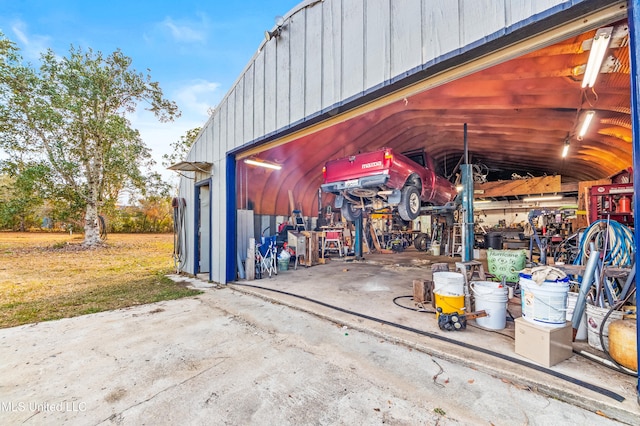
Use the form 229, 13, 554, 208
0, 0, 302, 178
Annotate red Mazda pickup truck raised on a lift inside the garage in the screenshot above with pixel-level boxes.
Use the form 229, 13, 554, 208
322, 148, 457, 221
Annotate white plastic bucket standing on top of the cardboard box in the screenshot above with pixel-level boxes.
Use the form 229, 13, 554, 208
520, 273, 569, 328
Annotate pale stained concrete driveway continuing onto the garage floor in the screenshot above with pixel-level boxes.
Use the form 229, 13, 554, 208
0, 253, 638, 425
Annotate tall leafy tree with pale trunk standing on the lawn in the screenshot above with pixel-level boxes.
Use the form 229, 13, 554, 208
0, 34, 180, 245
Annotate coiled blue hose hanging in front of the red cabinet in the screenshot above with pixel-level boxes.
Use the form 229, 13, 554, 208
574, 219, 635, 267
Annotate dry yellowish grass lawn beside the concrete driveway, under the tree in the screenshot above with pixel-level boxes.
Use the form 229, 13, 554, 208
0, 232, 200, 328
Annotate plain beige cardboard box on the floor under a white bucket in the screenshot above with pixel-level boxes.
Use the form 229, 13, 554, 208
515, 318, 573, 367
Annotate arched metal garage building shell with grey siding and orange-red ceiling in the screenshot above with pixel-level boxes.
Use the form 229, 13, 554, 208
173, 0, 640, 408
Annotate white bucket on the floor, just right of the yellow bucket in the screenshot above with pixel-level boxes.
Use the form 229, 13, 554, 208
469, 281, 509, 330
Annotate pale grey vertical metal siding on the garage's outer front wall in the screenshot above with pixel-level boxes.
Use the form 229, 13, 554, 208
180, 0, 592, 282
